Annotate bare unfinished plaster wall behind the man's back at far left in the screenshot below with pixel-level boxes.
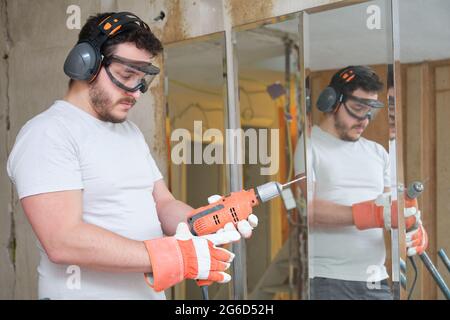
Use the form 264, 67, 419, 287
0, 0, 107, 299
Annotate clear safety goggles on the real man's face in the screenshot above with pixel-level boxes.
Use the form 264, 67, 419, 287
103, 55, 159, 93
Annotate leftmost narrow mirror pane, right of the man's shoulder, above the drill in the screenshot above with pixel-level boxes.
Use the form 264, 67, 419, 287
165, 33, 229, 299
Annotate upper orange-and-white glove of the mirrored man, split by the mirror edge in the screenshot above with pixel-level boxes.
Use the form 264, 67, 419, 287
352, 193, 420, 230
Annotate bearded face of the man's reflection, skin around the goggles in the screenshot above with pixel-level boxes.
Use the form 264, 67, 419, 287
333, 89, 378, 141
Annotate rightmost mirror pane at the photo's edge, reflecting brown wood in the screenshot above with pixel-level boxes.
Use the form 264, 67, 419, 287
394, 0, 450, 300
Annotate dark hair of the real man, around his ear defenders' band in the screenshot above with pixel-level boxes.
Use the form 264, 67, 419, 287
69, 12, 163, 87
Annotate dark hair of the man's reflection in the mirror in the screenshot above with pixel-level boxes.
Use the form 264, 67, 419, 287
330, 66, 383, 95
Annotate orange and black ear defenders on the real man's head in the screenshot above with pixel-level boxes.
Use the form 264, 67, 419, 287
64, 12, 148, 82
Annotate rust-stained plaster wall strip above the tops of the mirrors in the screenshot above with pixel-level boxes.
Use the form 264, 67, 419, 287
152, 0, 348, 43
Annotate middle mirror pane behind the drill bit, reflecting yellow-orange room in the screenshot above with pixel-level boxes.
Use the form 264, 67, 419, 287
234, 15, 307, 299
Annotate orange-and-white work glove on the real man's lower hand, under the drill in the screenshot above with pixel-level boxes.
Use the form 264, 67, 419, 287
144, 222, 241, 291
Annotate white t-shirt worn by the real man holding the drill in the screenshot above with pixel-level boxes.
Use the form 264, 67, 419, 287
8, 101, 165, 299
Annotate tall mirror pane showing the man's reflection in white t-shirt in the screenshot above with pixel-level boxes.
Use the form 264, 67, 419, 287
295, 1, 399, 300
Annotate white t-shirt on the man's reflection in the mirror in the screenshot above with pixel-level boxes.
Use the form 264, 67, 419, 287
295, 126, 390, 282
